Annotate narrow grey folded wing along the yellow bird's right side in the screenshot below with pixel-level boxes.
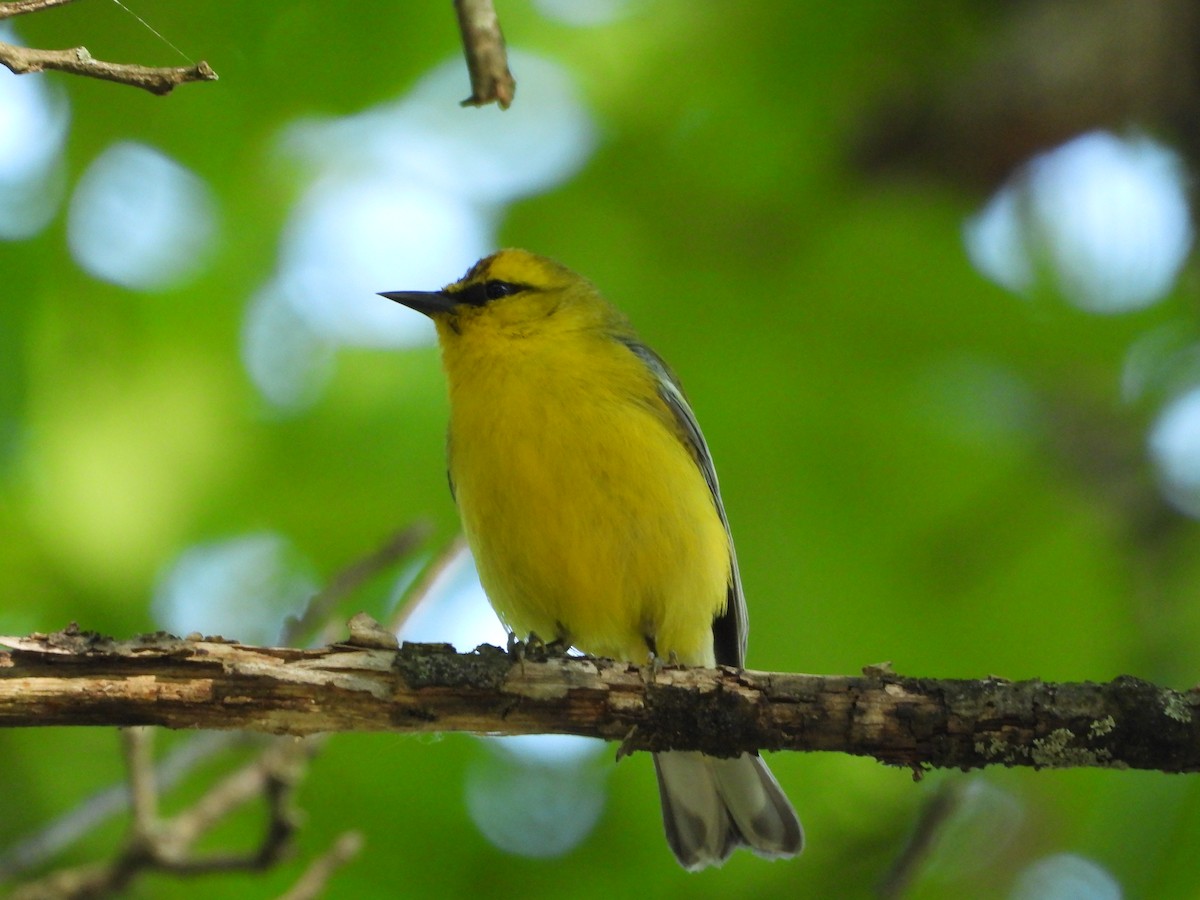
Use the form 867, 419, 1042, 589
623, 340, 750, 668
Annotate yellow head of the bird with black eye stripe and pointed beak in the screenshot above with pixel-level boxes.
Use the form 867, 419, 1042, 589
380, 250, 628, 344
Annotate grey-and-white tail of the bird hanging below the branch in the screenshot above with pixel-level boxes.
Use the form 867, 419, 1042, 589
654, 750, 804, 871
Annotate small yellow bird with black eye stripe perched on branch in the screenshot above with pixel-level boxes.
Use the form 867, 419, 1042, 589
380, 250, 804, 871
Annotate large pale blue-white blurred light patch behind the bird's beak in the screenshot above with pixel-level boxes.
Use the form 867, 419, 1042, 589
242, 52, 596, 409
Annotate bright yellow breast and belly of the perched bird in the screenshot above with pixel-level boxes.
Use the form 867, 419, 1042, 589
450, 340, 730, 665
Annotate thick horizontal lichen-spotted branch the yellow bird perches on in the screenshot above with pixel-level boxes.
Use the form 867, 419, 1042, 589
0, 629, 1200, 772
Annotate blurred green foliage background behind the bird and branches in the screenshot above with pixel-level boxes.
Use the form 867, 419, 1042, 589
0, 0, 1200, 898
